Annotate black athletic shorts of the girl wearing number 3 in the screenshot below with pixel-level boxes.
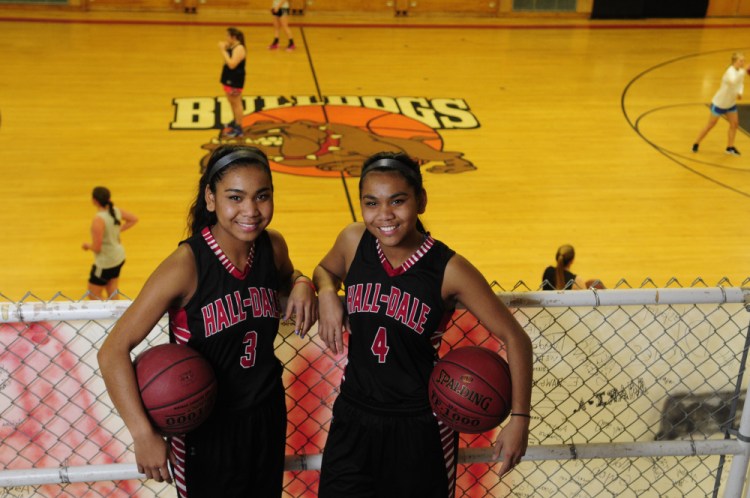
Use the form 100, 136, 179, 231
172, 382, 287, 498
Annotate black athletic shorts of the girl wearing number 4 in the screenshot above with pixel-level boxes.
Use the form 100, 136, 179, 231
318, 395, 458, 498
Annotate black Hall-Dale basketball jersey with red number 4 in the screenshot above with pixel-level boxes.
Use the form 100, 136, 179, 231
341, 231, 455, 412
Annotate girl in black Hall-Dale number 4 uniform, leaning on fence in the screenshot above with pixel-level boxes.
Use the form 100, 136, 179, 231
313, 153, 532, 498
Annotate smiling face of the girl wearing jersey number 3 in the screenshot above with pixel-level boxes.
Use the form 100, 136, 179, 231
205, 165, 273, 246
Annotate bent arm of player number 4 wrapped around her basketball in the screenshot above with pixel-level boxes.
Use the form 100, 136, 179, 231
443, 254, 532, 476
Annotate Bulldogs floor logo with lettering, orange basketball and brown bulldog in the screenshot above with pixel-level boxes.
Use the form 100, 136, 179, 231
170, 96, 479, 178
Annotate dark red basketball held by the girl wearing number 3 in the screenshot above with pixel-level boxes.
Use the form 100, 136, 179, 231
133, 344, 217, 436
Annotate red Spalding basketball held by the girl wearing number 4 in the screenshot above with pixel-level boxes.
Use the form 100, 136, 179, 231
428, 346, 511, 434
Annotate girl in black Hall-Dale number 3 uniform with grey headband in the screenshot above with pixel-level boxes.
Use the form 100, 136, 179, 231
98, 146, 317, 498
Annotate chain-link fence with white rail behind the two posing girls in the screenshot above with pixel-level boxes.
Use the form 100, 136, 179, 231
0, 280, 750, 497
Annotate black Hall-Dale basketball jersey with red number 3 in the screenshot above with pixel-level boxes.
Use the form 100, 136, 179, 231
169, 228, 282, 409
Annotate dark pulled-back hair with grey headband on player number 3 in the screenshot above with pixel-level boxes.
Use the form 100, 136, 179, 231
187, 145, 273, 236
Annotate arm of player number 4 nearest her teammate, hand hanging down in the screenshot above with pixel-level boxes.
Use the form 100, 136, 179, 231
313, 223, 365, 354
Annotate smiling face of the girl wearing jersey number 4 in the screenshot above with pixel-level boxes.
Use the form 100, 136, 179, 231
360, 171, 427, 256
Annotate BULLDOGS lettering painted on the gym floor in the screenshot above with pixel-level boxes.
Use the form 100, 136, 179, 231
170, 95, 479, 130
